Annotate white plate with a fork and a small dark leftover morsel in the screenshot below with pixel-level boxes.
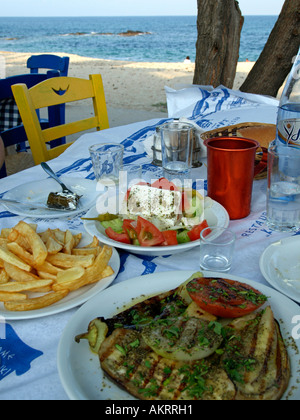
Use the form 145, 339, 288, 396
3, 176, 100, 219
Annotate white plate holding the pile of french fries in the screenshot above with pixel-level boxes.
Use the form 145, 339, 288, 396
0, 233, 120, 320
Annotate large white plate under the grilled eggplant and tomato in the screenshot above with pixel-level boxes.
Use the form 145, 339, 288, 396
57, 270, 300, 400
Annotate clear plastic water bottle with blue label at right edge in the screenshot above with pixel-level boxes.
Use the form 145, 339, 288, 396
276, 49, 300, 148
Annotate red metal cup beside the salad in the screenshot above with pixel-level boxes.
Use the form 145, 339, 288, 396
204, 137, 260, 220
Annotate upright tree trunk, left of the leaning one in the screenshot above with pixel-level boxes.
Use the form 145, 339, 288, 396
193, 0, 244, 88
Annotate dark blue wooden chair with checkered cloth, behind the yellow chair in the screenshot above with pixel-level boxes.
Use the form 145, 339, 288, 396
0, 70, 60, 178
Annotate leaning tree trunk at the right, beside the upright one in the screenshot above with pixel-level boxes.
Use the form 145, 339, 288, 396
240, 0, 300, 97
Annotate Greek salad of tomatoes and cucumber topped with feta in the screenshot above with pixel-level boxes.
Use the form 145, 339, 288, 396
84, 178, 209, 247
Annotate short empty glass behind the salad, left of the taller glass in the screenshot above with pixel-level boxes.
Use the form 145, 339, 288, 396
89, 143, 124, 185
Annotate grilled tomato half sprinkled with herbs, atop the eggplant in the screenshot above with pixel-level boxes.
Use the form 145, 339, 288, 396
187, 277, 267, 318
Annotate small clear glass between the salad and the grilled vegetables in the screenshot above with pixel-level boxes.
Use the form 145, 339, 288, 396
200, 227, 236, 272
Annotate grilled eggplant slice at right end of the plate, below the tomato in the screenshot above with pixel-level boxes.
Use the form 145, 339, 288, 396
222, 306, 290, 400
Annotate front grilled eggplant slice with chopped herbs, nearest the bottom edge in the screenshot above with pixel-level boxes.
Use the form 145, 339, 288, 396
99, 329, 236, 400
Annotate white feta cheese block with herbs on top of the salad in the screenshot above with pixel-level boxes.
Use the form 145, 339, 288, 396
122, 185, 181, 230
